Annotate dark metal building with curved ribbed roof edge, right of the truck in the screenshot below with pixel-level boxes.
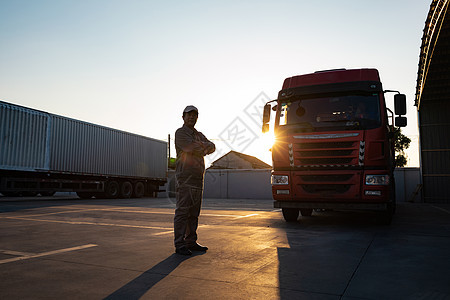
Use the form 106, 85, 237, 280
416, 1, 450, 203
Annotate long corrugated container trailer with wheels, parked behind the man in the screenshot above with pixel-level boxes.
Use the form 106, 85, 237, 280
0, 101, 167, 198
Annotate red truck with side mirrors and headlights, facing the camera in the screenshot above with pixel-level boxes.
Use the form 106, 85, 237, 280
263, 69, 406, 223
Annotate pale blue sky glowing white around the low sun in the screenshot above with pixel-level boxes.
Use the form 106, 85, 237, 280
0, 0, 431, 167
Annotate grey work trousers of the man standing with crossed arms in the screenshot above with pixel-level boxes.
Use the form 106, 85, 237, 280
173, 184, 203, 248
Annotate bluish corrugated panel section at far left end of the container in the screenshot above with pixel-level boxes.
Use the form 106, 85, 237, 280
0, 102, 50, 170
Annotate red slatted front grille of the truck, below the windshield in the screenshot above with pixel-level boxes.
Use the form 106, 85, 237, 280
288, 132, 365, 201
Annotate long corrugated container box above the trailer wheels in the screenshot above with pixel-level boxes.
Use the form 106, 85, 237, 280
0, 102, 167, 178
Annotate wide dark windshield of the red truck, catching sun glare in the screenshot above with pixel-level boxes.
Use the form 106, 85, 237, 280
278, 94, 381, 132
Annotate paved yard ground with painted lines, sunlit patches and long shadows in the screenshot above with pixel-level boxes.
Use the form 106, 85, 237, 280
0, 197, 450, 299
